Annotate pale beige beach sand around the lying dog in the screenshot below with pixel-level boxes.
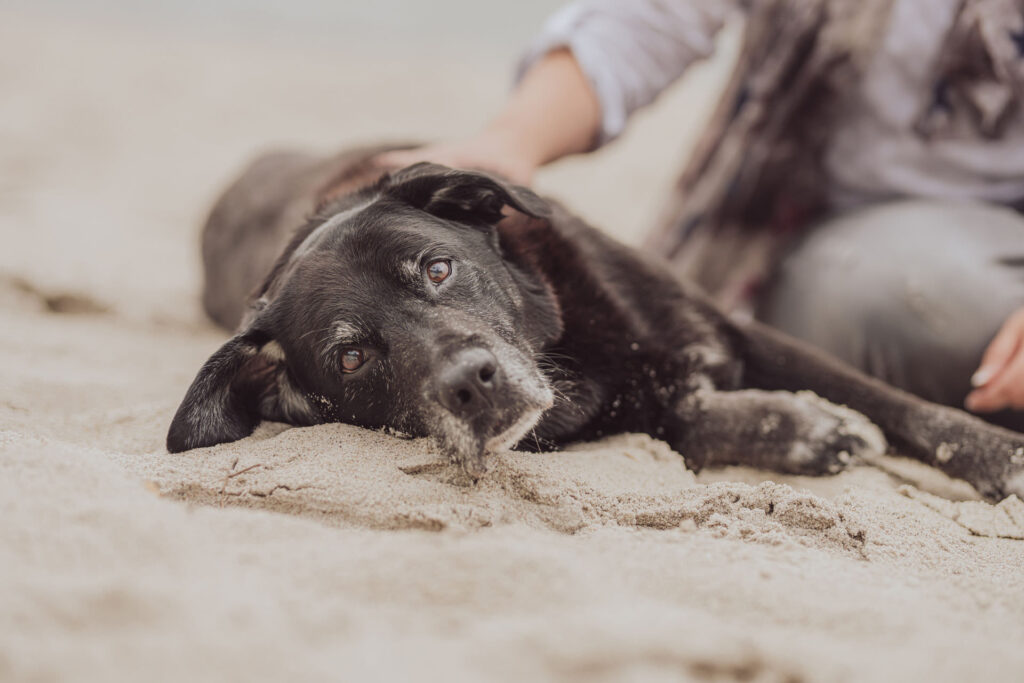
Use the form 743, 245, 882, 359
0, 13, 1024, 681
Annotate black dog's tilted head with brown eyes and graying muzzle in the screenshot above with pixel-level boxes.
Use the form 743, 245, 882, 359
167, 164, 561, 475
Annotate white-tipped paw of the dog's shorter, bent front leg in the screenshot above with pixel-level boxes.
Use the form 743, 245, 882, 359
781, 392, 887, 476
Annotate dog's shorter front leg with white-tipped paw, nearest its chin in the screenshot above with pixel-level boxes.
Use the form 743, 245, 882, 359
670, 389, 886, 475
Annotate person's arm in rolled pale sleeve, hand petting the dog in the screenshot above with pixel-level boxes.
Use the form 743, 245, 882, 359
382, 0, 734, 182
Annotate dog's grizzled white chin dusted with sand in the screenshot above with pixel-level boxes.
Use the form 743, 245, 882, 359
432, 400, 551, 480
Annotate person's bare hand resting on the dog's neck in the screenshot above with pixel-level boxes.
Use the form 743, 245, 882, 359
377, 130, 538, 185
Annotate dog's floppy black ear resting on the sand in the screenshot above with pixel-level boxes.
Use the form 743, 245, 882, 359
167, 331, 317, 453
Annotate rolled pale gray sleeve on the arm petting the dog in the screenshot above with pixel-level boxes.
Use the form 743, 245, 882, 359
516, 0, 736, 145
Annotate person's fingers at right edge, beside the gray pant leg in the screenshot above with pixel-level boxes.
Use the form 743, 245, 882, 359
964, 308, 1024, 413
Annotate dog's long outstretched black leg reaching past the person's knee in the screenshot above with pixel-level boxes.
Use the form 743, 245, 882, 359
737, 323, 1024, 498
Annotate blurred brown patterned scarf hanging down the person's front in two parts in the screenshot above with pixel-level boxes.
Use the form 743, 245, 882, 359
646, 0, 1024, 310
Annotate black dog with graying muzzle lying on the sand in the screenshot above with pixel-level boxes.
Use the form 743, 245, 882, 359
167, 150, 1024, 499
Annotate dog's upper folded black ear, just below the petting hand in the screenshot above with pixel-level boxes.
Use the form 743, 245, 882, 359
385, 162, 548, 224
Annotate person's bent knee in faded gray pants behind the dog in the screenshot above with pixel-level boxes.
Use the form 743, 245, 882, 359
756, 200, 1024, 429
